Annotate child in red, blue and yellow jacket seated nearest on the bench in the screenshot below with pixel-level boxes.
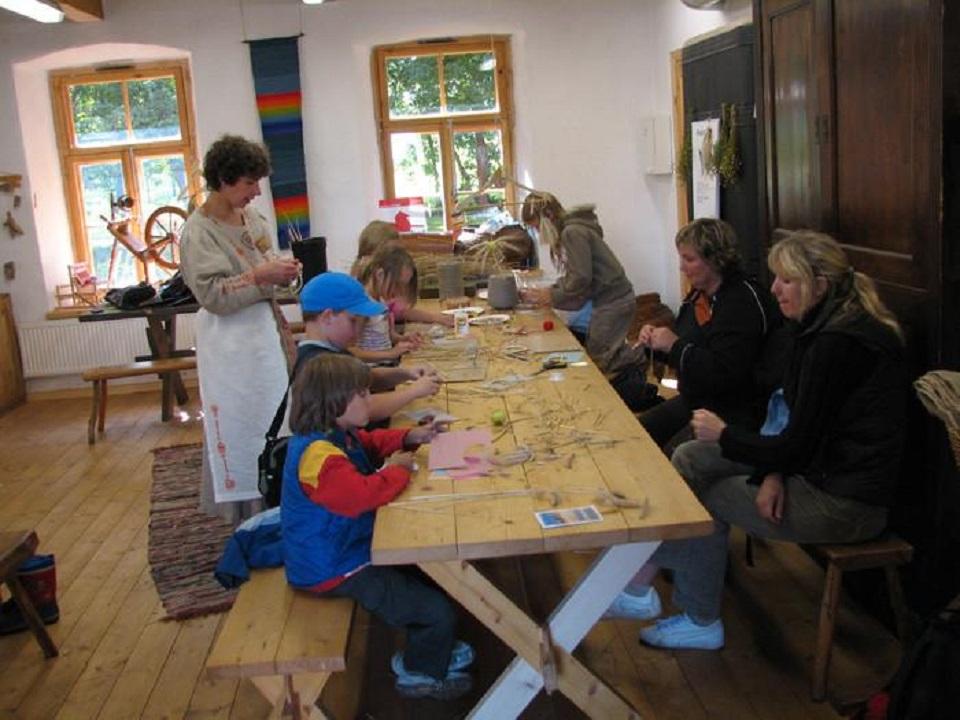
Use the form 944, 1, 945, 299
280, 353, 474, 699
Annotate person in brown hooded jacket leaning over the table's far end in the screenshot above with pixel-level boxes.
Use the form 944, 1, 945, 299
521, 191, 641, 380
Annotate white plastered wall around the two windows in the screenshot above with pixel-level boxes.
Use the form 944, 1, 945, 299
0, 0, 750, 321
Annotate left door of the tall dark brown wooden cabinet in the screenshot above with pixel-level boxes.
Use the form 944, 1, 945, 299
757, 0, 833, 229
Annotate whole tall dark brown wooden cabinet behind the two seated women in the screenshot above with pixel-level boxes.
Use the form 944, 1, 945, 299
757, 0, 942, 367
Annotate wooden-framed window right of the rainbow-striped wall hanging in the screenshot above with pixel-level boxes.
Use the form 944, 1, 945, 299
373, 36, 514, 232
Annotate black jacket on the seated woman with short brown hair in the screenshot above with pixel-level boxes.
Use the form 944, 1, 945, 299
667, 274, 781, 428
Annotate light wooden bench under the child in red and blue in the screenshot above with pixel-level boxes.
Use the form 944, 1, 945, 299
207, 568, 368, 718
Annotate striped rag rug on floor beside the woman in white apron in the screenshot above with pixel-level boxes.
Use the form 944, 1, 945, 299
147, 444, 237, 620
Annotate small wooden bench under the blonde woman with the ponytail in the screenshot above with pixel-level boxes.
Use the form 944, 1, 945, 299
805, 534, 913, 700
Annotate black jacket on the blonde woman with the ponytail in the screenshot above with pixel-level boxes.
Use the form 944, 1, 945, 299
720, 299, 908, 506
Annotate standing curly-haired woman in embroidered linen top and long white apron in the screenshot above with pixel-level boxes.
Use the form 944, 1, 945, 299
180, 135, 300, 524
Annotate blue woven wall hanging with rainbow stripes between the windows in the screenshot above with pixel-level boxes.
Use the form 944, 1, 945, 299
249, 36, 310, 248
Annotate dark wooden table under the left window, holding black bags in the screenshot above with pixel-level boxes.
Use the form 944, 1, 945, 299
77, 303, 200, 422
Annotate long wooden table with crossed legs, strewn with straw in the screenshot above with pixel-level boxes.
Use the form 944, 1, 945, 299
373, 312, 712, 720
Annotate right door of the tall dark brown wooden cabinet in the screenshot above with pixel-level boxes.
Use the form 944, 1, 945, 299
833, 0, 941, 290
